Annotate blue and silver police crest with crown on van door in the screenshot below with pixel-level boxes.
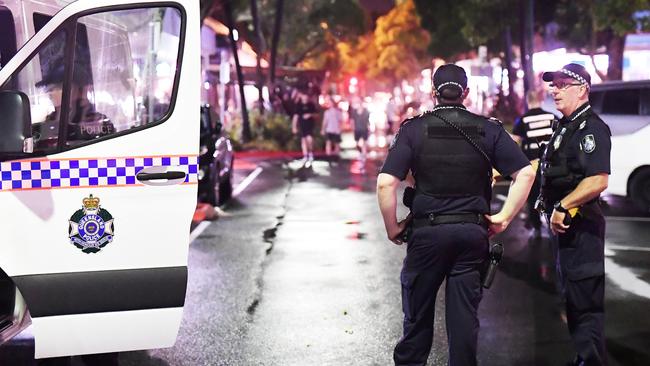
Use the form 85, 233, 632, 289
68, 194, 114, 253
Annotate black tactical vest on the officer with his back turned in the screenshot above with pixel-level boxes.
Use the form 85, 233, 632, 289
414, 108, 492, 207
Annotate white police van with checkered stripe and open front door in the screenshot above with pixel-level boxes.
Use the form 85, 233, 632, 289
0, 0, 200, 358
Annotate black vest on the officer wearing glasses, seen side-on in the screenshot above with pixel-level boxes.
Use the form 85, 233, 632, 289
540, 113, 590, 203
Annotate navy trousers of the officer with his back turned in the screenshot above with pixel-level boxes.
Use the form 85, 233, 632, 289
393, 224, 488, 366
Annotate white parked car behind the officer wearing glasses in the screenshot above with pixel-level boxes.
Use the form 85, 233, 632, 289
589, 80, 650, 212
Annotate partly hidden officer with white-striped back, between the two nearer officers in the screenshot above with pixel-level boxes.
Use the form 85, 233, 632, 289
512, 90, 557, 238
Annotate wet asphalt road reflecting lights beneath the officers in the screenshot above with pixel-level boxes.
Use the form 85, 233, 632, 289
0, 153, 650, 366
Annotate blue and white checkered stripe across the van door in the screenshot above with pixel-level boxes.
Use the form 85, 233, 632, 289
0, 155, 198, 191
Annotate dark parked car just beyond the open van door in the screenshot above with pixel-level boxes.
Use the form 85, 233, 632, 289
198, 104, 234, 206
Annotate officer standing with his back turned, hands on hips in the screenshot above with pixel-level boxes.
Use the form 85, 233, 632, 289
377, 64, 534, 366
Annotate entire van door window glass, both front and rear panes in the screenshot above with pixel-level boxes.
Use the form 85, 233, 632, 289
2, 7, 184, 154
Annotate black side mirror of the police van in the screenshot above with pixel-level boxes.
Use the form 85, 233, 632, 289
0, 90, 34, 154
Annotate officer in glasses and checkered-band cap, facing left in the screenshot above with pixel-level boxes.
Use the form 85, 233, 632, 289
540, 64, 611, 366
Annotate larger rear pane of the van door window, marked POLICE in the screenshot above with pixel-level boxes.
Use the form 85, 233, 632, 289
66, 8, 181, 146
